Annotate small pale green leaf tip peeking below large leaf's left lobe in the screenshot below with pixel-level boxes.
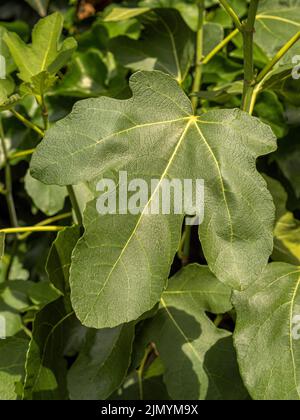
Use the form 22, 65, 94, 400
25, 172, 68, 216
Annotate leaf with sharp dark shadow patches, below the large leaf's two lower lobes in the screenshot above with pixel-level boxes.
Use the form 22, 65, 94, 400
135, 266, 247, 400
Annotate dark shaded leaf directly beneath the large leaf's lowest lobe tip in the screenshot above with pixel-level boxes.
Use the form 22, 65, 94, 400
68, 324, 134, 401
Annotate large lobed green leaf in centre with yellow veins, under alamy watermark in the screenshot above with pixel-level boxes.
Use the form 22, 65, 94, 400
31, 72, 276, 328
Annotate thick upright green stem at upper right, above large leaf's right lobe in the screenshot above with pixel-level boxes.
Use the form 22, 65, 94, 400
242, 0, 259, 112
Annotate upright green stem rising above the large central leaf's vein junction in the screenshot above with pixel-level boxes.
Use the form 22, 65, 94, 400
192, 0, 205, 114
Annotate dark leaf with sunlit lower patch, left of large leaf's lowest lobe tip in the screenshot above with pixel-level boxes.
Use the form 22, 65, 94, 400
24, 298, 74, 400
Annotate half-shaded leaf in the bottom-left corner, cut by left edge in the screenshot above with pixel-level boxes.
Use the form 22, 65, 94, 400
0, 338, 28, 400
